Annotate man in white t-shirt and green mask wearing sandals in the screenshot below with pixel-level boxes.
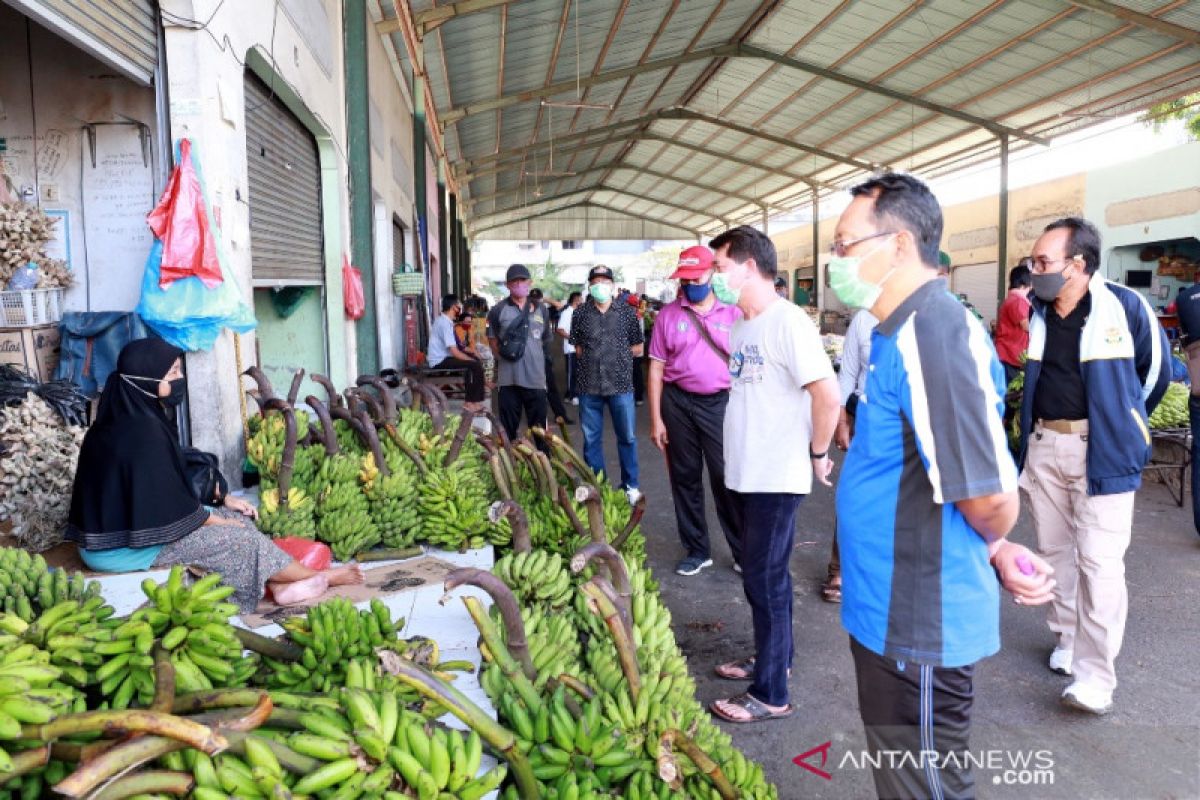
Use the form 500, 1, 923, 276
709, 225, 841, 722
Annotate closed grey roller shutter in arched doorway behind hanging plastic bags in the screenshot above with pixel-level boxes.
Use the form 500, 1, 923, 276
246, 72, 325, 285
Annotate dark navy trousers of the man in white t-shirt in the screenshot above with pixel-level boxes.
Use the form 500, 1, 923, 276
731, 492, 804, 705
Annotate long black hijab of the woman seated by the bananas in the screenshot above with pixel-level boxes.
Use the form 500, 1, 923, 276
67, 338, 208, 551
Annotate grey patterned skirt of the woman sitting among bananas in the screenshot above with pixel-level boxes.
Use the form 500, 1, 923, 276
154, 509, 292, 614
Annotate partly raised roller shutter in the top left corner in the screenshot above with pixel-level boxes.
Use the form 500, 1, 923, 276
7, 0, 158, 85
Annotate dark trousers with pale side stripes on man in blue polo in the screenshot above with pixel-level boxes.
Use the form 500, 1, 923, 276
850, 638, 976, 800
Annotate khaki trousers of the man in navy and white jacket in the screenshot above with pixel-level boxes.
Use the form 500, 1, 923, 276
1020, 425, 1134, 691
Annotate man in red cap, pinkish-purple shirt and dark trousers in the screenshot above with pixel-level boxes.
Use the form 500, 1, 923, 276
647, 245, 742, 575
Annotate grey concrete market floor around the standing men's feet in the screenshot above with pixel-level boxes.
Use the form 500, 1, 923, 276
571, 393, 1200, 800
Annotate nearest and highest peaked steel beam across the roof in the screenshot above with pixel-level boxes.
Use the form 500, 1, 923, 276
440, 43, 1041, 145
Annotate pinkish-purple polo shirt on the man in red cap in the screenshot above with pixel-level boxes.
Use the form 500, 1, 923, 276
650, 297, 742, 395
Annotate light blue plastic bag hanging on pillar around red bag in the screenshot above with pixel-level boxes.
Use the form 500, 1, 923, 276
137, 143, 258, 353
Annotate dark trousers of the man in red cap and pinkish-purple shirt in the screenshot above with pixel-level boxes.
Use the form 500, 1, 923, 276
662, 384, 742, 564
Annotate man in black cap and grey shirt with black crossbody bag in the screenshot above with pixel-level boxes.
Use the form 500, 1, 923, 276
487, 264, 553, 447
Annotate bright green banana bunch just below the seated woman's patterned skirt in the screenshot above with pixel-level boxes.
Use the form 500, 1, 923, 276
94, 566, 258, 709
